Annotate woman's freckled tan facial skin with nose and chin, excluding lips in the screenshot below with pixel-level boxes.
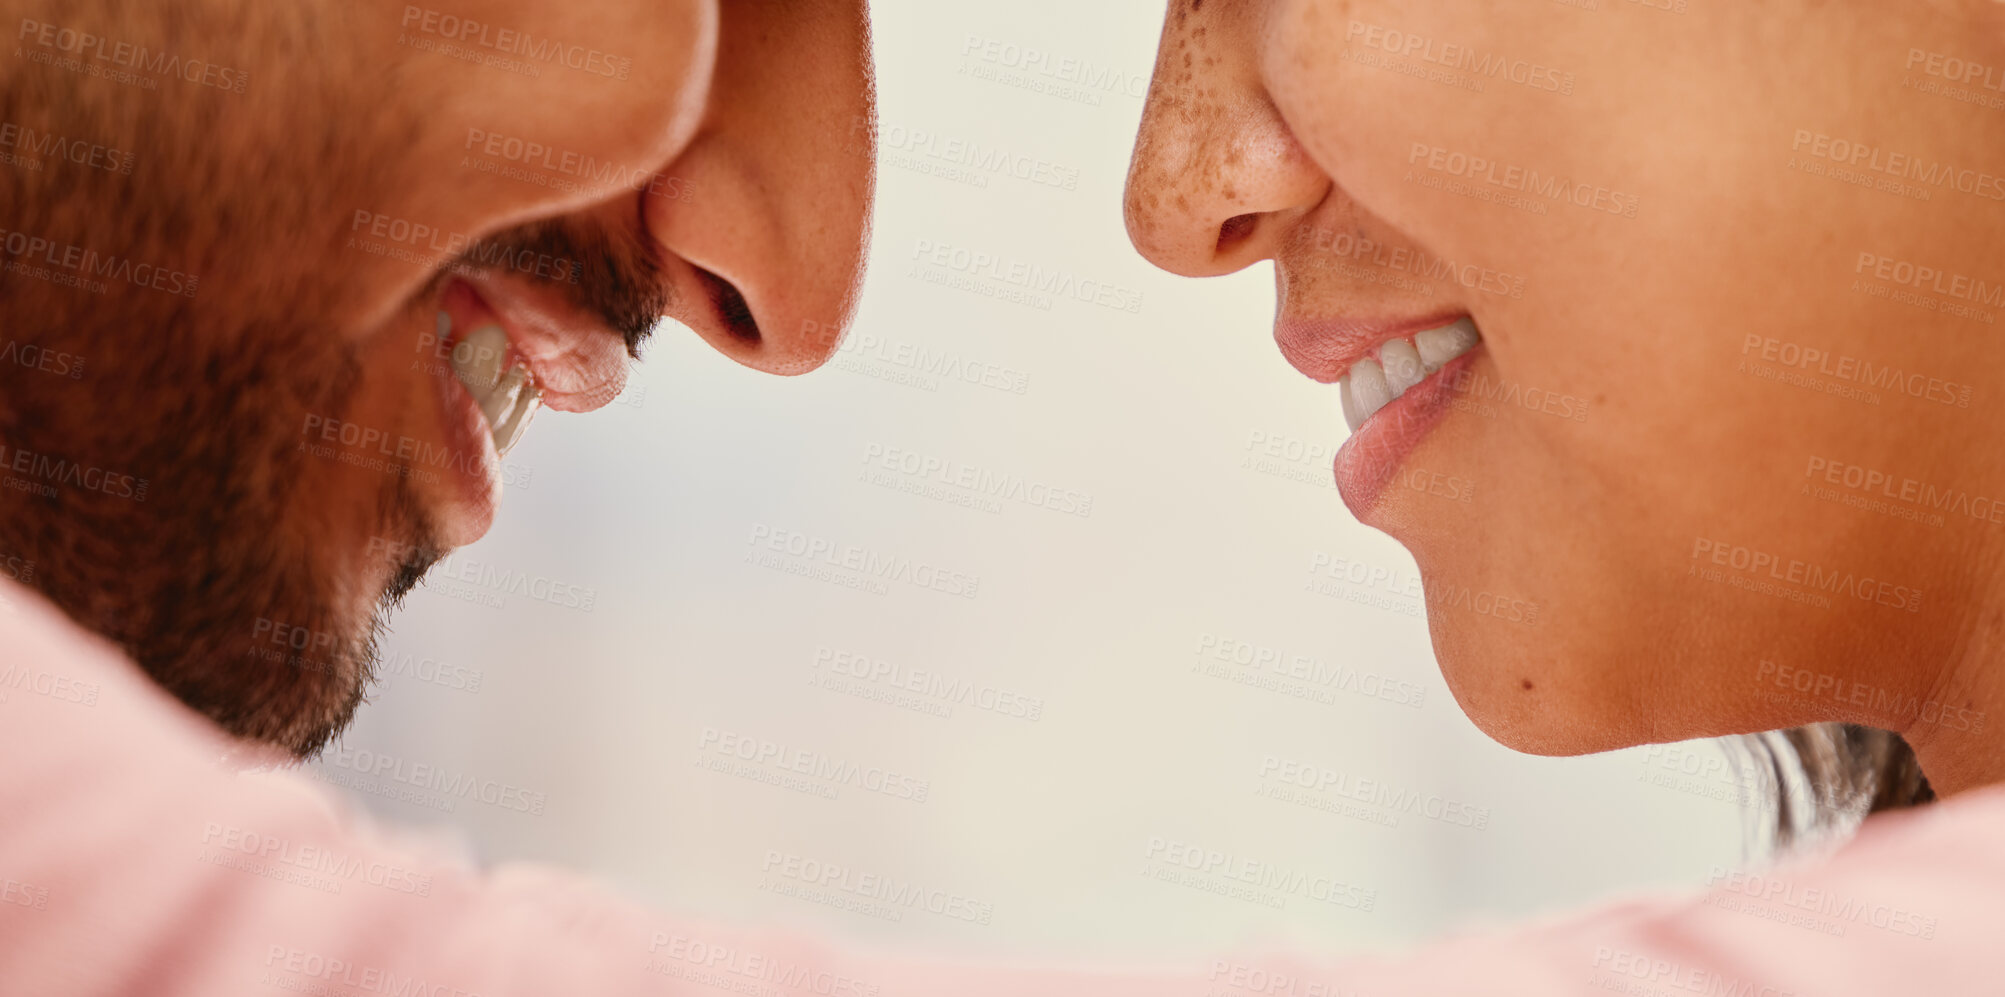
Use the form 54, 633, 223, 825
1125, 0, 2005, 792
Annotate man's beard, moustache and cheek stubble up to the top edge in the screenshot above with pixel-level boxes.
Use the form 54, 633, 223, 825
0, 0, 668, 756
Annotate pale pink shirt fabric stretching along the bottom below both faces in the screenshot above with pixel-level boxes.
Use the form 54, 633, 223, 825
0, 582, 2005, 997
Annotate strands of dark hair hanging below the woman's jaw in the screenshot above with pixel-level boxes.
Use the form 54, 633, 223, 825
1740, 724, 1935, 849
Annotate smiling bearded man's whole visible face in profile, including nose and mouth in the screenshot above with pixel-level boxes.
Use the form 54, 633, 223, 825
0, 0, 874, 754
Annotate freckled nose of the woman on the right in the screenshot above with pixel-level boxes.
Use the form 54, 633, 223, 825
1125, 4, 1331, 277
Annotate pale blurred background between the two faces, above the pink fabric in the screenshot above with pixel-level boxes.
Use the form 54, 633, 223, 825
313, 0, 1764, 959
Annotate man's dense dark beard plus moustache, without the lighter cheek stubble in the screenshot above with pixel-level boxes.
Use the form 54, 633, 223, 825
0, 223, 668, 758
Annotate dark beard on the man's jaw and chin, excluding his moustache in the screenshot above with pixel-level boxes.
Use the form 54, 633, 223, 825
0, 301, 394, 754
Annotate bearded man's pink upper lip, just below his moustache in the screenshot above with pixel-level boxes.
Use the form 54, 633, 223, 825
455, 273, 628, 411
